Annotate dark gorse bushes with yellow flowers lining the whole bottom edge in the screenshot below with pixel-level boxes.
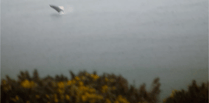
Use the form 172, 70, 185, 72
1, 70, 208, 103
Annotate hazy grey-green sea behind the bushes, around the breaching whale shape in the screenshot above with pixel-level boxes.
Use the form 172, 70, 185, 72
1, 0, 208, 98
